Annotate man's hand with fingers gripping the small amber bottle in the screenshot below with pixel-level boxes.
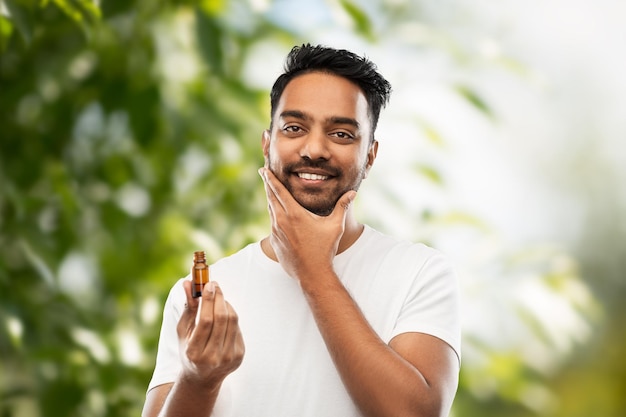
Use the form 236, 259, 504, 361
177, 281, 245, 389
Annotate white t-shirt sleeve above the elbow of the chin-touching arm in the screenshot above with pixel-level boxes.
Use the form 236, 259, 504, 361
392, 247, 461, 361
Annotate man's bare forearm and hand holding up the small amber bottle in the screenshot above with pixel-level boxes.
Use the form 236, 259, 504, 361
142, 281, 244, 417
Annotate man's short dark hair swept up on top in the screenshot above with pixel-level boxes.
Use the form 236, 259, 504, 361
270, 44, 391, 139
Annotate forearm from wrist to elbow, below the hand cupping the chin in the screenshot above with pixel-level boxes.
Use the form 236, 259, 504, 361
302, 272, 441, 416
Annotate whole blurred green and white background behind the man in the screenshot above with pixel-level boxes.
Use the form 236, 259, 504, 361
0, 0, 626, 417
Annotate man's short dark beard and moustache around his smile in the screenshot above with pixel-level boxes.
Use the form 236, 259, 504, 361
268, 153, 367, 217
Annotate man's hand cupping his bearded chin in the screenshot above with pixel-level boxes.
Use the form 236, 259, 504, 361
259, 168, 356, 279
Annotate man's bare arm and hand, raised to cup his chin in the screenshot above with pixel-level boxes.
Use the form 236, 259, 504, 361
262, 170, 458, 417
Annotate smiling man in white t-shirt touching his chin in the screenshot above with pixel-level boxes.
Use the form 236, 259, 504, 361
143, 45, 460, 417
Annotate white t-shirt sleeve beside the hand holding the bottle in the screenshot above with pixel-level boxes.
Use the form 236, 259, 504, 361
148, 278, 185, 391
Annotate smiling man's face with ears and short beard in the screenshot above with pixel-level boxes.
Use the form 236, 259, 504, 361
263, 72, 378, 216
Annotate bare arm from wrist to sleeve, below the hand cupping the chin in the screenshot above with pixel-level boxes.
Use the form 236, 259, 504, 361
303, 274, 458, 416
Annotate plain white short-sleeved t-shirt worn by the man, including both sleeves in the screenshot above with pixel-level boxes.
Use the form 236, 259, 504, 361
148, 226, 461, 417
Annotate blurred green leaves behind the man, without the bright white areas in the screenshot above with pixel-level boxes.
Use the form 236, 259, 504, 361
0, 0, 610, 417
